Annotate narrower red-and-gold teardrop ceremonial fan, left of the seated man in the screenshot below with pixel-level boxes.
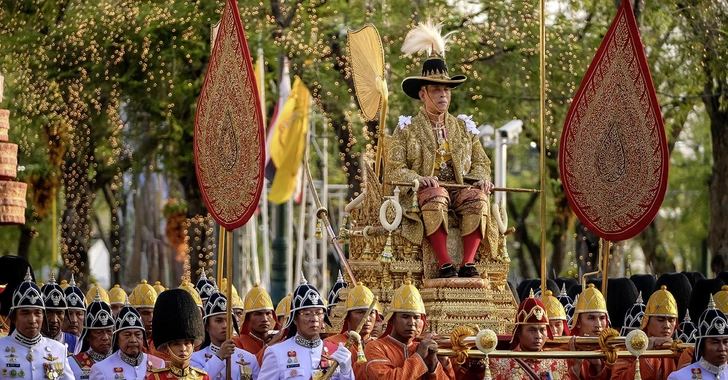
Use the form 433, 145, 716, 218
194, 0, 265, 230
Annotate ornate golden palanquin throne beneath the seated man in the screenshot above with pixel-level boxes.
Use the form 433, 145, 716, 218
332, 162, 517, 335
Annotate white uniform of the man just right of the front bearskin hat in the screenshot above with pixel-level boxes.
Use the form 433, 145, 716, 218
190, 345, 260, 380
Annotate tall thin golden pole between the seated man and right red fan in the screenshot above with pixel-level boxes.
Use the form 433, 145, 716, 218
538, 0, 546, 296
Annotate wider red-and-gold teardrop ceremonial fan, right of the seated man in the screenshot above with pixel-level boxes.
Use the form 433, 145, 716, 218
559, 0, 669, 241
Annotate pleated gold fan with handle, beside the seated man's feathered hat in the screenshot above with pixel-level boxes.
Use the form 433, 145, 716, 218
347, 24, 388, 176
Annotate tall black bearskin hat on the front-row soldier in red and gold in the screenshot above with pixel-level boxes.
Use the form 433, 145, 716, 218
152, 289, 205, 351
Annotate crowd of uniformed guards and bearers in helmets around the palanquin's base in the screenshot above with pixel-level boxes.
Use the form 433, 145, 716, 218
0, 252, 728, 380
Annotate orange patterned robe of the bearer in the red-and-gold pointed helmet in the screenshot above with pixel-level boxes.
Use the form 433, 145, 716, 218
490, 347, 571, 380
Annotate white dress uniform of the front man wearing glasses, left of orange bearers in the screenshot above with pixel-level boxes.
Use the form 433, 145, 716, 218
259, 336, 354, 380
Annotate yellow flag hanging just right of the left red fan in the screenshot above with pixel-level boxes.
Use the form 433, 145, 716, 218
268, 77, 311, 204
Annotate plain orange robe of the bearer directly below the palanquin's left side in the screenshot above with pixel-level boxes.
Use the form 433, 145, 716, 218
364, 335, 455, 380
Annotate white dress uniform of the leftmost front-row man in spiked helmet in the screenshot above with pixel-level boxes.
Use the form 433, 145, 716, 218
0, 331, 75, 380
